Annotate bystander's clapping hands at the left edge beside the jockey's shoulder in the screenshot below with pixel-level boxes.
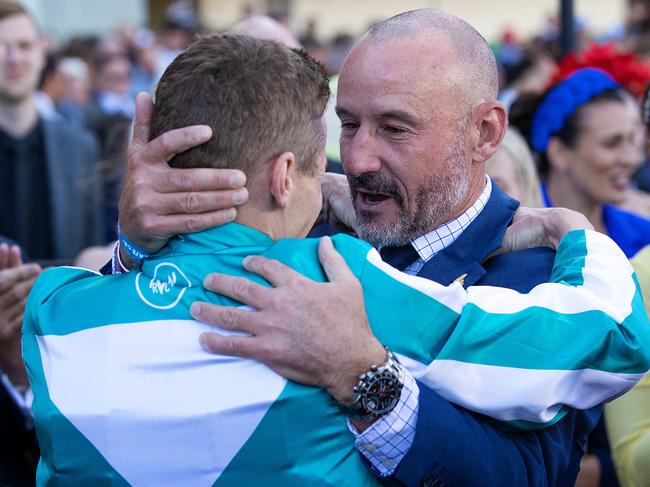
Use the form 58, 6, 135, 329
0, 244, 41, 386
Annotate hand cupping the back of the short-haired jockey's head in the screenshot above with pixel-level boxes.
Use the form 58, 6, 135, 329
119, 93, 248, 264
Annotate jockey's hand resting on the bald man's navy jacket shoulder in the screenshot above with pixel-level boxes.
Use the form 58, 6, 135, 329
493, 207, 594, 255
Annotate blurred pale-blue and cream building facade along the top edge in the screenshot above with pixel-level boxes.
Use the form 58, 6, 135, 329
17, 0, 626, 44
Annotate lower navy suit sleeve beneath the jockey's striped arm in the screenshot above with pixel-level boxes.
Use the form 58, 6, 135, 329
379, 385, 600, 487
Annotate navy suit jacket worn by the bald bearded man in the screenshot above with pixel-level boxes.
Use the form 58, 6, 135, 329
383, 185, 601, 487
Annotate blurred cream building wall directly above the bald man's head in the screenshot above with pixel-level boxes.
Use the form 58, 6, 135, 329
195, 0, 625, 39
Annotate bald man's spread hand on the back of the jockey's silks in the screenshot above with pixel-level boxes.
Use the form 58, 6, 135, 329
190, 237, 386, 403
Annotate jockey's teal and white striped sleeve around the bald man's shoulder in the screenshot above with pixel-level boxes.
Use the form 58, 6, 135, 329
362, 231, 650, 430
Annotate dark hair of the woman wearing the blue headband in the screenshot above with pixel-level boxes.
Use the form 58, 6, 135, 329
509, 88, 632, 177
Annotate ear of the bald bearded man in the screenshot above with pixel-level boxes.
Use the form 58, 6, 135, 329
472, 101, 508, 162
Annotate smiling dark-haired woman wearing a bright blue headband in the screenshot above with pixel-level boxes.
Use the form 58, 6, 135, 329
510, 68, 650, 257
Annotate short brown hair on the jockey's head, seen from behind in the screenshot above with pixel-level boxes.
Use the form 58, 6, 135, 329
151, 35, 330, 175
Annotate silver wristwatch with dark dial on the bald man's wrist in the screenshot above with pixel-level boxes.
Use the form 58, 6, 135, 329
338, 348, 404, 421
